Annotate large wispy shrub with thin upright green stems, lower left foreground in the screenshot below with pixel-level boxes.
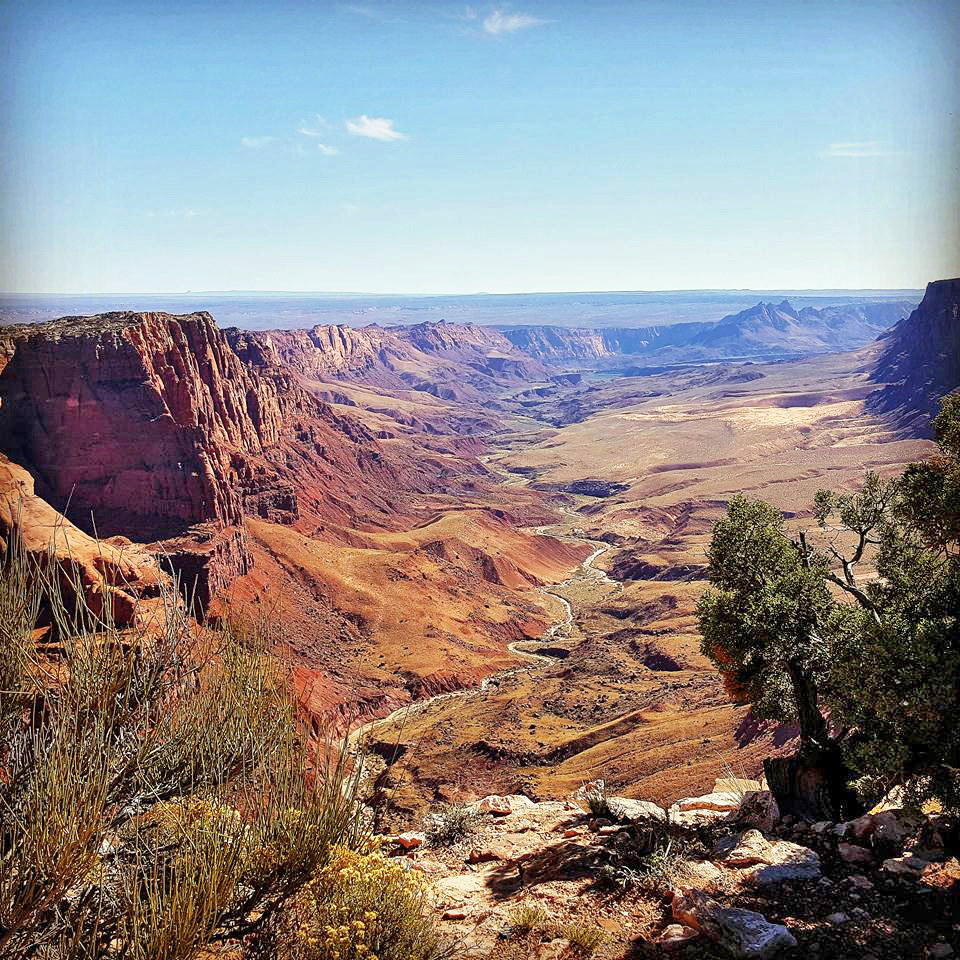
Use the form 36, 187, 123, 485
0, 531, 362, 960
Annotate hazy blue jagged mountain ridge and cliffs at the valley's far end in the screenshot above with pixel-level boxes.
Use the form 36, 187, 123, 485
499, 300, 915, 366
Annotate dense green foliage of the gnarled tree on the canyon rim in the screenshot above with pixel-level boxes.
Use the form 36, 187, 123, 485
698, 397, 960, 805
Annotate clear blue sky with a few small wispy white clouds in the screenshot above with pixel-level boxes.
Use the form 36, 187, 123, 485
0, 0, 960, 293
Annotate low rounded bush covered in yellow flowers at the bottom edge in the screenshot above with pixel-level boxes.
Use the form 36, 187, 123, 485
287, 847, 450, 960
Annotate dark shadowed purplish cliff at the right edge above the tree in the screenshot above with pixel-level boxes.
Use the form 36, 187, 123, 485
870, 279, 960, 435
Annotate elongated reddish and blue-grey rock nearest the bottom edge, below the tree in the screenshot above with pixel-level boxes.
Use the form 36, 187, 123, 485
673, 890, 797, 960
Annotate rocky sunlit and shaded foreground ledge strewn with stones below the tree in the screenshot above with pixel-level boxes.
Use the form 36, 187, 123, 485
376, 780, 960, 960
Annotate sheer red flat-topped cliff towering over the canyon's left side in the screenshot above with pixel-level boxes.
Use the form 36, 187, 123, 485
0, 312, 440, 607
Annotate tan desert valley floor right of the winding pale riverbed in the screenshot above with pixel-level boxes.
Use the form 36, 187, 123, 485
340, 344, 930, 811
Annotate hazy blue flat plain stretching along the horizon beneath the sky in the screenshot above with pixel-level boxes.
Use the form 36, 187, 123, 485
0, 290, 923, 330
